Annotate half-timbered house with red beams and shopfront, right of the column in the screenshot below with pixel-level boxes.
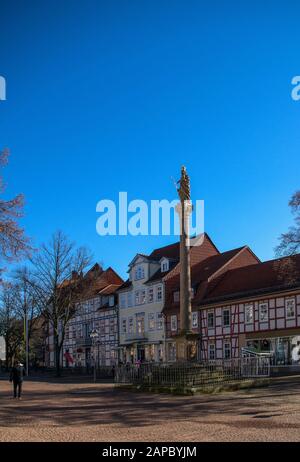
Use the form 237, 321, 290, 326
198, 255, 300, 365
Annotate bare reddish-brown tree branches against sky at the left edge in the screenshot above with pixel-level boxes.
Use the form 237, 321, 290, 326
0, 149, 30, 268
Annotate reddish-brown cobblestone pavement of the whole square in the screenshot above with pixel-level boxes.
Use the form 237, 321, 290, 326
0, 377, 300, 442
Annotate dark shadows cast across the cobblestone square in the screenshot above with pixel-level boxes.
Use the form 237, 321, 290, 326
0, 378, 300, 428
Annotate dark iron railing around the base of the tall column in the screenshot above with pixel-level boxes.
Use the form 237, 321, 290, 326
115, 358, 270, 387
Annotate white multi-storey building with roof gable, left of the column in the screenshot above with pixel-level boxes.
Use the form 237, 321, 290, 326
118, 254, 176, 363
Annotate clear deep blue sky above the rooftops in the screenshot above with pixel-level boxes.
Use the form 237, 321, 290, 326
0, 0, 300, 276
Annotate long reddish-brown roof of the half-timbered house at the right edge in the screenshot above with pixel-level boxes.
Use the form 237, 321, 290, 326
201, 254, 300, 305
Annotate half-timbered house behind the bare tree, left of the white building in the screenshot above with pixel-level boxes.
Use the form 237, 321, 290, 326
46, 264, 123, 368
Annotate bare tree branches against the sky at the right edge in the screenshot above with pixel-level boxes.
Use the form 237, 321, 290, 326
275, 191, 300, 256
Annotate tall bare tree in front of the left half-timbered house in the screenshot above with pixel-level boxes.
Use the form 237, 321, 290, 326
31, 231, 91, 376
